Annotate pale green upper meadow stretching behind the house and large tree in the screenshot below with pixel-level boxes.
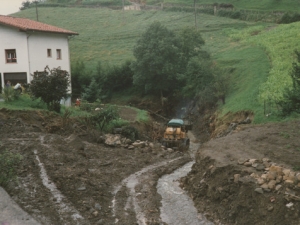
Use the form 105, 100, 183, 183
15, 8, 248, 69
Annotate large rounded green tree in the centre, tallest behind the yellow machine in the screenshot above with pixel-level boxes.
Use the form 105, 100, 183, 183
131, 22, 180, 95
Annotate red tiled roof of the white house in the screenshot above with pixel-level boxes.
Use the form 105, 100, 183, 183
0, 15, 78, 35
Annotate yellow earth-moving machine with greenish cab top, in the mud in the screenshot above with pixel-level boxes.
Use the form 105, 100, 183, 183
162, 119, 192, 150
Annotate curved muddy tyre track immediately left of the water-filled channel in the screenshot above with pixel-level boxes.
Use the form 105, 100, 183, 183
111, 155, 191, 225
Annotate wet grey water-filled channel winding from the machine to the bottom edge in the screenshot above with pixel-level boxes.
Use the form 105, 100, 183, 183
157, 135, 214, 225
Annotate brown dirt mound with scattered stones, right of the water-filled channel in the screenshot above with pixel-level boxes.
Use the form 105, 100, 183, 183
181, 121, 300, 225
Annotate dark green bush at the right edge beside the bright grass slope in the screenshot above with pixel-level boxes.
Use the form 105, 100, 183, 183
278, 50, 300, 116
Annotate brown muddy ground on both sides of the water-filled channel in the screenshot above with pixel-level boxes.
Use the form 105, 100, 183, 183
0, 109, 300, 225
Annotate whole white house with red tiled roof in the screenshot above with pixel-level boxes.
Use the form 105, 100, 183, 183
0, 15, 78, 105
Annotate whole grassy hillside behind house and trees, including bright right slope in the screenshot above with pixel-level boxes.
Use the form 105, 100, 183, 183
15, 8, 300, 123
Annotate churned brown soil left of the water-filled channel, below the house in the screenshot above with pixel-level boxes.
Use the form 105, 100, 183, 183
0, 108, 191, 225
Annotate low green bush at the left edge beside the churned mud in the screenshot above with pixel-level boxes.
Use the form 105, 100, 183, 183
0, 151, 22, 185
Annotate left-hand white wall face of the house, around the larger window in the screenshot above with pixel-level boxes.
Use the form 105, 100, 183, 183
0, 25, 29, 84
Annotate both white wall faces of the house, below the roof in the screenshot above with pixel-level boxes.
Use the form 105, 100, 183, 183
0, 25, 71, 105
